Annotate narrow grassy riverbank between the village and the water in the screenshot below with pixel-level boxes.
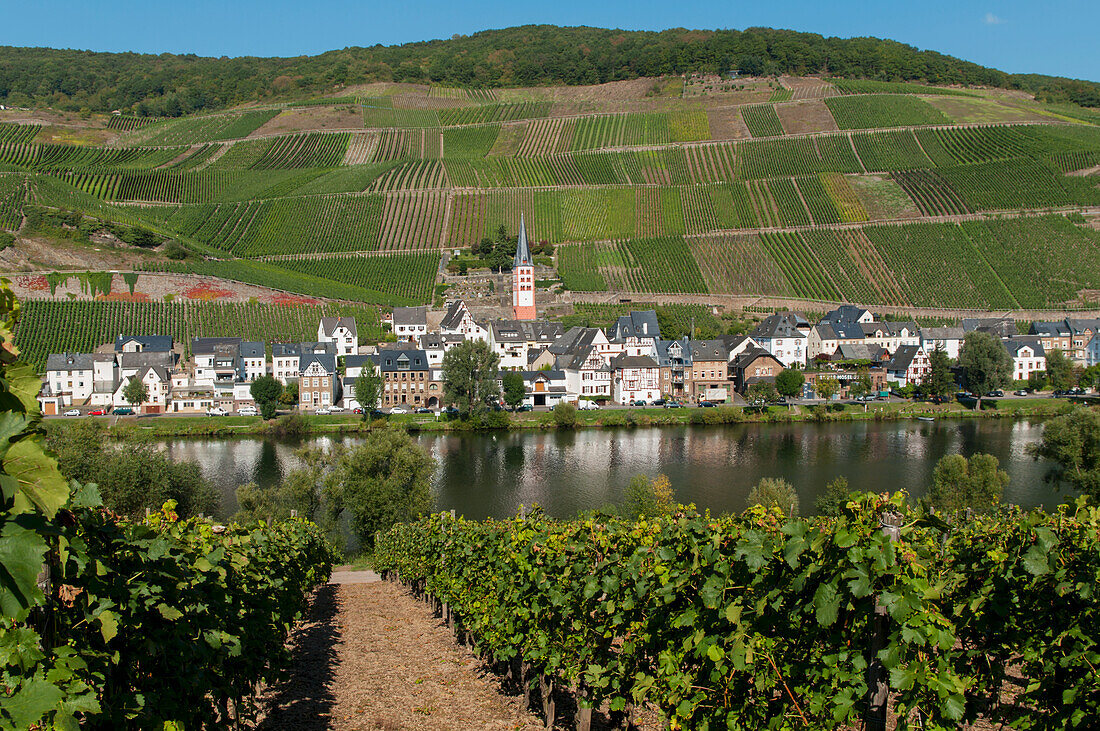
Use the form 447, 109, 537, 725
46, 398, 1082, 440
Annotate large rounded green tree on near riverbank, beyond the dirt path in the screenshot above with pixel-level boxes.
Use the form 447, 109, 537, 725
319, 428, 435, 549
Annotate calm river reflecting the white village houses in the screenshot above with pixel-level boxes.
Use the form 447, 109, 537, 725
164, 419, 1069, 519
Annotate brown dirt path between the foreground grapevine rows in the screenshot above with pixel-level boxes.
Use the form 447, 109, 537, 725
261, 582, 542, 731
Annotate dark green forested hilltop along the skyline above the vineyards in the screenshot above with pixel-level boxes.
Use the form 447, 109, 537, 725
0, 25, 1100, 117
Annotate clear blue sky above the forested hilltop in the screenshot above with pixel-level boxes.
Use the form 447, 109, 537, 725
0, 0, 1100, 80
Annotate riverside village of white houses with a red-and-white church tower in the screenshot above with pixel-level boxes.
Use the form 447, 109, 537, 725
39, 219, 1100, 416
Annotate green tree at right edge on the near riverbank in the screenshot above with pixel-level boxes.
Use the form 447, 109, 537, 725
1029, 406, 1100, 500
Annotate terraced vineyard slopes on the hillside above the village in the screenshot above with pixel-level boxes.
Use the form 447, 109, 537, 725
0, 77, 1100, 308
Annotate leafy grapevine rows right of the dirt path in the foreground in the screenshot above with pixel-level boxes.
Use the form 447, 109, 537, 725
375, 495, 1100, 730
